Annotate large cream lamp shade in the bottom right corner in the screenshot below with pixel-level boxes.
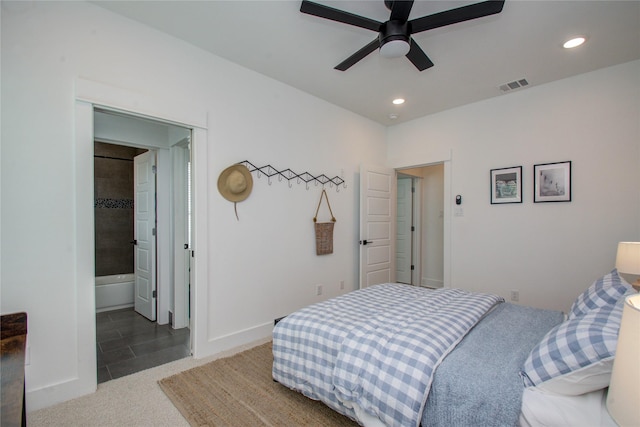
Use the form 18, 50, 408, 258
607, 294, 640, 427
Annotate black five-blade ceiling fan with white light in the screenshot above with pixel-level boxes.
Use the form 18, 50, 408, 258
300, 0, 504, 71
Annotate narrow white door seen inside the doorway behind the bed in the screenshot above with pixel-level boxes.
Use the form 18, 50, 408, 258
396, 176, 413, 284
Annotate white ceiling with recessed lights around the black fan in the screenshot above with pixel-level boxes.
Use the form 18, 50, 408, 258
93, 0, 640, 125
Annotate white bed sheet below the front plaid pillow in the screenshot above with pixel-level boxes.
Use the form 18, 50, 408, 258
520, 387, 617, 427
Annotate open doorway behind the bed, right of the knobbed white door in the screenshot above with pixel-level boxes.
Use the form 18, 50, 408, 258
396, 163, 445, 288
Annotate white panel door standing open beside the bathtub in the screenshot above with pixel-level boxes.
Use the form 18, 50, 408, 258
133, 150, 156, 321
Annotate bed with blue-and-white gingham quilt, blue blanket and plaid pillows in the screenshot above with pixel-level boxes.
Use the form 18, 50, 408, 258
272, 270, 634, 427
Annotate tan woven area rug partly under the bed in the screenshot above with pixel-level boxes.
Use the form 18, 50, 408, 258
159, 342, 358, 427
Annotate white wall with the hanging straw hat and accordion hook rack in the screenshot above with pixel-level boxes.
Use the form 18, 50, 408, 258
1, 2, 386, 410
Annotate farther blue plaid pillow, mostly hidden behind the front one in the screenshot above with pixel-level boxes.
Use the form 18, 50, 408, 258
568, 268, 633, 320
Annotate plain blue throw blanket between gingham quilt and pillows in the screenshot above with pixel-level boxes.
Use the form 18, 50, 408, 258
422, 303, 564, 427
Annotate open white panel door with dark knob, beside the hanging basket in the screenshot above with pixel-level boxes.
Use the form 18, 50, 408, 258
360, 165, 396, 288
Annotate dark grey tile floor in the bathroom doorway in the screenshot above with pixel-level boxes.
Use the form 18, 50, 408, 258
96, 308, 190, 384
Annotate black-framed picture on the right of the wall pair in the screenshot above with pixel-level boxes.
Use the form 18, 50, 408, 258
533, 162, 571, 203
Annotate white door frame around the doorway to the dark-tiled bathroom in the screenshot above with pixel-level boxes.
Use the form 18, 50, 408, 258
75, 78, 209, 398
